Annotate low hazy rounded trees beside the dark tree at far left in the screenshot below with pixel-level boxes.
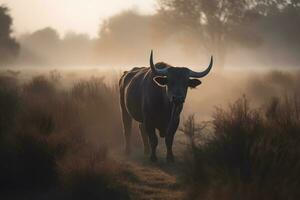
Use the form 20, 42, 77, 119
18, 27, 95, 66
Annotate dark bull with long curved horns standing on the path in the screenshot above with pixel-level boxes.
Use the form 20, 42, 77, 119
119, 51, 213, 162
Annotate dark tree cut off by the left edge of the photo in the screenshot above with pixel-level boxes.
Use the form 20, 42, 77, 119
0, 6, 20, 63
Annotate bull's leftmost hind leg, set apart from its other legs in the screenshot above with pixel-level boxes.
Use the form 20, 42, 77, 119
122, 108, 132, 155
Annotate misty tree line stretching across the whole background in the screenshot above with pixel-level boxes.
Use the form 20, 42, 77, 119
0, 0, 300, 67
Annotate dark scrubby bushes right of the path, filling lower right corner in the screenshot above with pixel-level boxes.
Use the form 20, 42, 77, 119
185, 94, 300, 199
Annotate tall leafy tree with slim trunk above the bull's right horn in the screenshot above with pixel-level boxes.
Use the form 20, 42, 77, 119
158, 0, 261, 66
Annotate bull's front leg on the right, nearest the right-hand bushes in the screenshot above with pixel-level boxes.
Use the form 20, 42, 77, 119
165, 119, 179, 162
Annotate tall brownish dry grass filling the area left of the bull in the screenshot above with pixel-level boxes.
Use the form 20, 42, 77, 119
0, 73, 129, 199
